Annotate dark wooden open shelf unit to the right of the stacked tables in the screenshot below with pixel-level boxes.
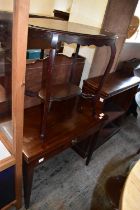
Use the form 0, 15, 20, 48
74, 72, 140, 154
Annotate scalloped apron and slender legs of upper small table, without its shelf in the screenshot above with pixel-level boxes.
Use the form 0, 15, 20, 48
34, 29, 116, 139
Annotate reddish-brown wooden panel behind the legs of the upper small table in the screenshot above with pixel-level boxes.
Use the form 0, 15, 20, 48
25, 54, 85, 108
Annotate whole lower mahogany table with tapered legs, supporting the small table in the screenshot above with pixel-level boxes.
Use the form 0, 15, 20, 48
23, 100, 106, 208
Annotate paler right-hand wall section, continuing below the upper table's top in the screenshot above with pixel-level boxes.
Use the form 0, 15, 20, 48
65, 0, 108, 86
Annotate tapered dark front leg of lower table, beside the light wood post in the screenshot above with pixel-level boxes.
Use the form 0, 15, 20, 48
23, 161, 34, 209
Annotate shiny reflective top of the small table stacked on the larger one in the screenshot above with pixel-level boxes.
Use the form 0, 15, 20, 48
0, 11, 117, 40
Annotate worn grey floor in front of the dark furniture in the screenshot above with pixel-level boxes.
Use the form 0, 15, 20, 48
12, 112, 140, 210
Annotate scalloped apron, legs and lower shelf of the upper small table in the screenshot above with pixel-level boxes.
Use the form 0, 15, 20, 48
33, 29, 116, 139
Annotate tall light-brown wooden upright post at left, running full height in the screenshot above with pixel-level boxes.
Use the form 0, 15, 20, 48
12, 0, 29, 208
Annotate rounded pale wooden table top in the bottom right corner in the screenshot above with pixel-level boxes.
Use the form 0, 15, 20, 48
120, 159, 140, 210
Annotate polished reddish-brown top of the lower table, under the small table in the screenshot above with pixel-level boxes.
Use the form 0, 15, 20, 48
23, 102, 105, 163
